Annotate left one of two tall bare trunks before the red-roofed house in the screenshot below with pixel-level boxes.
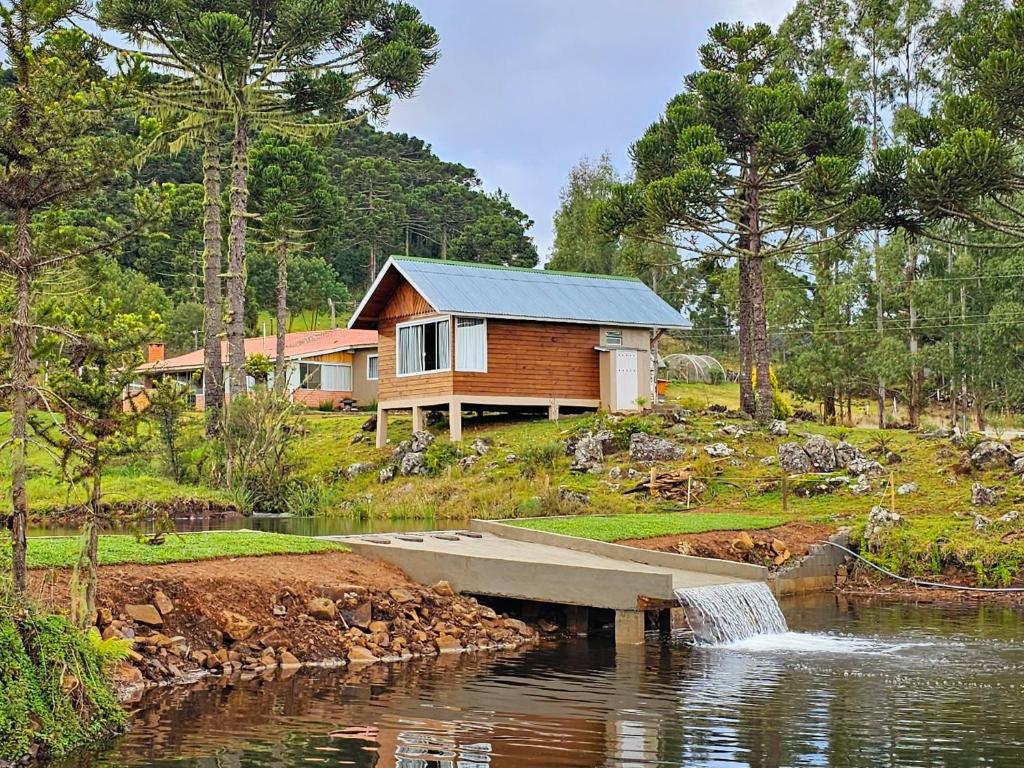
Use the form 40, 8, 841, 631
203, 128, 224, 437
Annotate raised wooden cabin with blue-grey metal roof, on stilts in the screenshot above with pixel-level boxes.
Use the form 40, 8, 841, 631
349, 256, 683, 447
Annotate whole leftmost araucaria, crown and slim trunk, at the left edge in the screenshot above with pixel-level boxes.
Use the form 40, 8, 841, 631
0, 0, 133, 592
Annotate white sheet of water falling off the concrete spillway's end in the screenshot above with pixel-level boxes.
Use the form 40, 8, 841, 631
676, 582, 790, 645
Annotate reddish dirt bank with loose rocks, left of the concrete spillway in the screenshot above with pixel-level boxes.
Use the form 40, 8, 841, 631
33, 552, 554, 693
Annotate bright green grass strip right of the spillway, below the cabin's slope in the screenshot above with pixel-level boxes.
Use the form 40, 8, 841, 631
509, 512, 790, 542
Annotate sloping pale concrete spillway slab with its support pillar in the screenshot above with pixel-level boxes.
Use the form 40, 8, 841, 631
323, 520, 768, 643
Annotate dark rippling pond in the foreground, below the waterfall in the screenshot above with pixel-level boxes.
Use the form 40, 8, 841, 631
62, 595, 1024, 768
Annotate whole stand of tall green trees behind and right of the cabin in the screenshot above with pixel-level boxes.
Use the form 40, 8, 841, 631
548, 0, 1024, 429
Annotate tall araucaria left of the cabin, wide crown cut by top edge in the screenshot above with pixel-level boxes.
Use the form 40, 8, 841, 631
100, 0, 437, 403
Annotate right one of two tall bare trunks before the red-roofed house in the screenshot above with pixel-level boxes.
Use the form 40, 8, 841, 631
227, 115, 249, 397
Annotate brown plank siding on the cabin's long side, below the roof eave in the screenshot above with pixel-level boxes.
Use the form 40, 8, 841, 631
453, 319, 601, 400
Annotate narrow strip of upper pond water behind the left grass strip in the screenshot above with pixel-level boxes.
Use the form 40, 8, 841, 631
28, 515, 469, 537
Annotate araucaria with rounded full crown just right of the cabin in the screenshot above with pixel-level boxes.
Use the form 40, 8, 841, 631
598, 24, 877, 422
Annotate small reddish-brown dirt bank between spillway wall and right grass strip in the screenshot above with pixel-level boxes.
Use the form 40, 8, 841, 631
616, 521, 835, 566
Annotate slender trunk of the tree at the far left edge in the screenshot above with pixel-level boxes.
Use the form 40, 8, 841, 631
10, 208, 32, 595
